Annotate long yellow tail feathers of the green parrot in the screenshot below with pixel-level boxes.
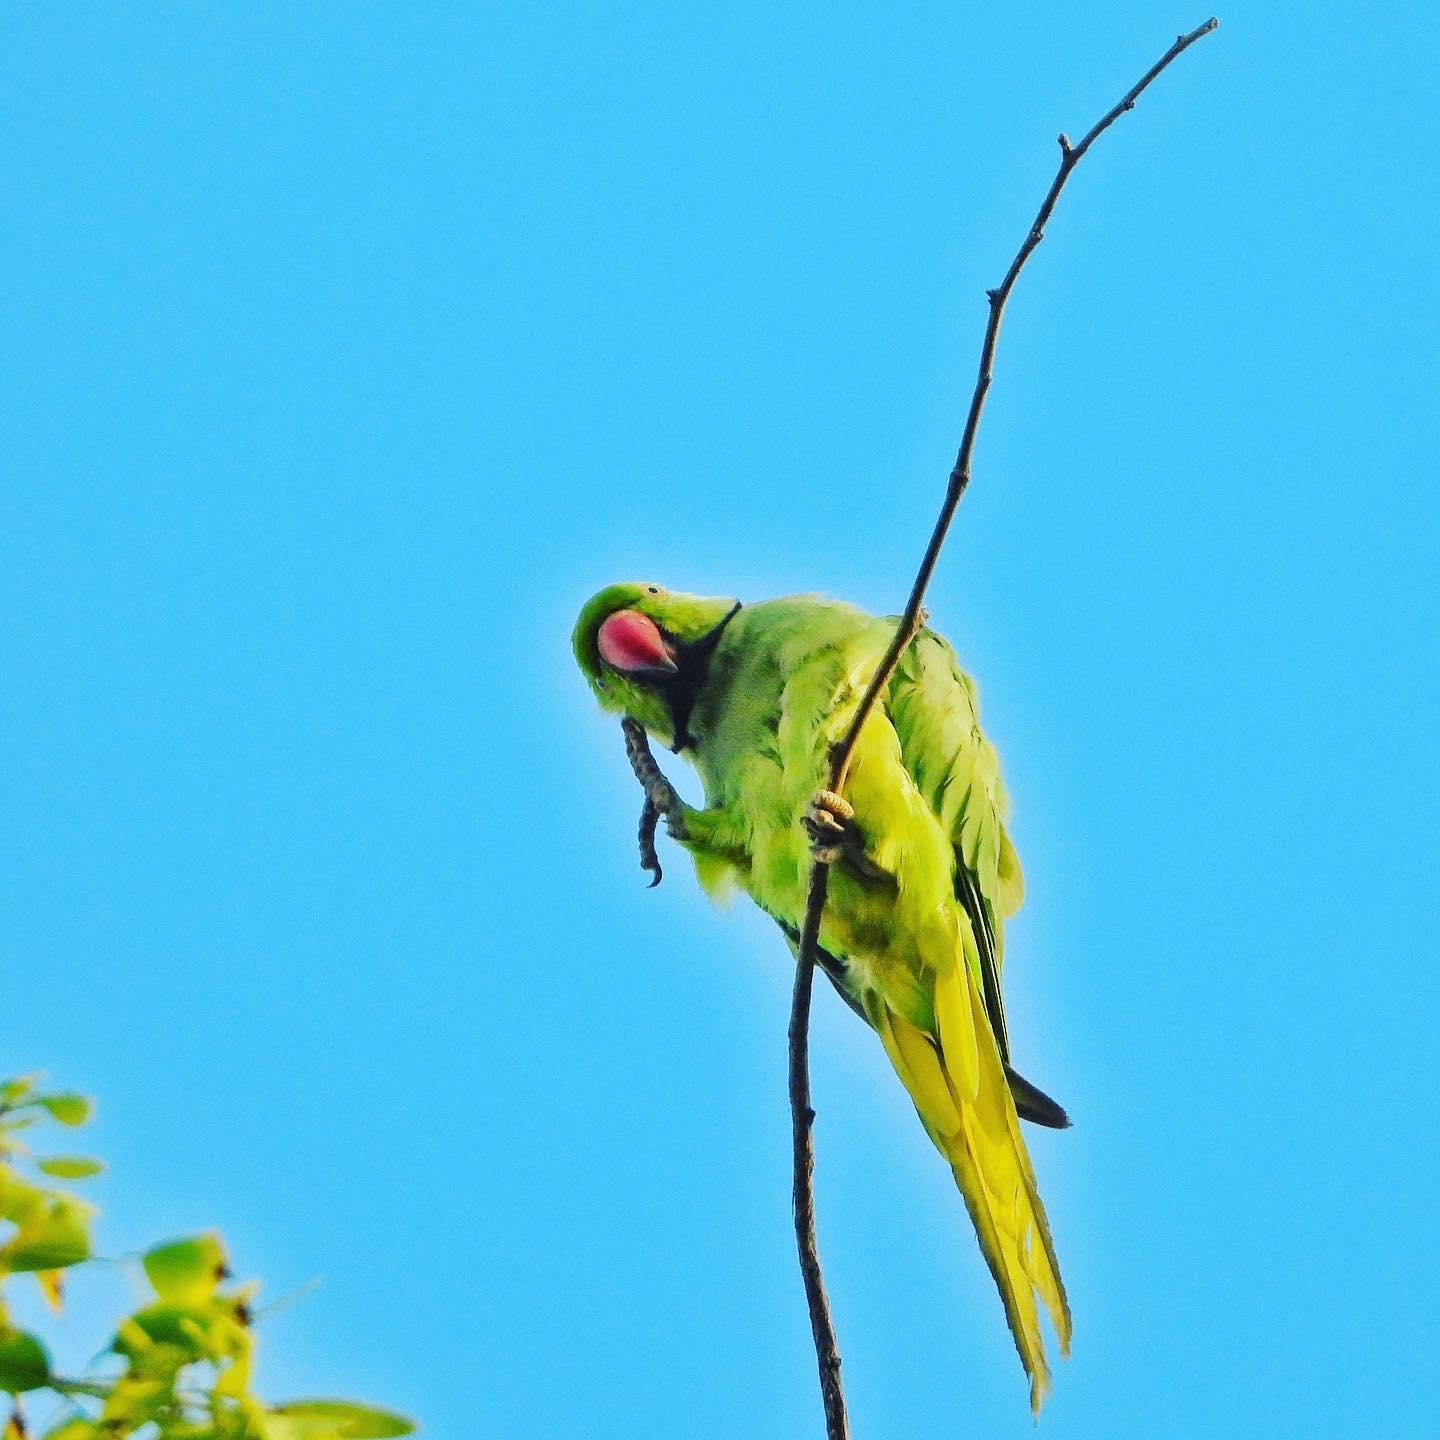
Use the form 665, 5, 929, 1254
865, 962, 1070, 1416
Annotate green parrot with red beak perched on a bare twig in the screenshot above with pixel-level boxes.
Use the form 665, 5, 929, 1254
573, 583, 1070, 1414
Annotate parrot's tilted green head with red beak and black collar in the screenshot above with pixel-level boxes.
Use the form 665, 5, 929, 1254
573, 582, 740, 750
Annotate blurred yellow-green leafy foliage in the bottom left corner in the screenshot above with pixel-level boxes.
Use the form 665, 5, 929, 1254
0, 1074, 415, 1440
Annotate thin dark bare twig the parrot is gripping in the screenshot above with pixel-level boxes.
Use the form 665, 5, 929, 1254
789, 17, 1220, 1440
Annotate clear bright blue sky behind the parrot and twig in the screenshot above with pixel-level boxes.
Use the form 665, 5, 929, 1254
0, 0, 1440, 1440
